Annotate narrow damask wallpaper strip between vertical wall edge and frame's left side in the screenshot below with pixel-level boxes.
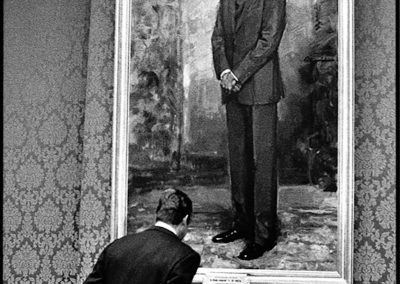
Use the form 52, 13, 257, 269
78, 0, 115, 283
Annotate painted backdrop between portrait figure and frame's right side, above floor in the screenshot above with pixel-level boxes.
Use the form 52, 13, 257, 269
278, 0, 338, 186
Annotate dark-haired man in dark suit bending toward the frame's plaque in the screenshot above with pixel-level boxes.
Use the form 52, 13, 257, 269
84, 189, 200, 284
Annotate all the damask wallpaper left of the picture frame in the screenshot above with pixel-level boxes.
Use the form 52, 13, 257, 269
3, 0, 115, 283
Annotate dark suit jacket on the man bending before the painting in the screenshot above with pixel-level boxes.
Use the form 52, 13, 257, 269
84, 226, 200, 284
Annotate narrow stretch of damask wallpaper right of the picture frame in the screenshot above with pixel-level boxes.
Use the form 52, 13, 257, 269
354, 0, 396, 283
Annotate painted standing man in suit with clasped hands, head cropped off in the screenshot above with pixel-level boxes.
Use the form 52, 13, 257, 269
212, 0, 286, 260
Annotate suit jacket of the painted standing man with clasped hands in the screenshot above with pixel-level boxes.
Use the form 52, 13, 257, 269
211, 0, 286, 105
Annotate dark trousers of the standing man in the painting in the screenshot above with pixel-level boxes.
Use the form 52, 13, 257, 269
226, 101, 277, 245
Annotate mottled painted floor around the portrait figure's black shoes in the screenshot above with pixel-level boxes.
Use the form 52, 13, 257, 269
128, 185, 337, 271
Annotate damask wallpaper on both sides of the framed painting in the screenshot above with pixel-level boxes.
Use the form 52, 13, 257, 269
3, 0, 396, 284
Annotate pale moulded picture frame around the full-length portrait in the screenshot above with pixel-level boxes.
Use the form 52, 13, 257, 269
110, 0, 354, 284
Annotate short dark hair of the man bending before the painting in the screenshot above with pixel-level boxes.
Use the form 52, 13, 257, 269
156, 188, 192, 225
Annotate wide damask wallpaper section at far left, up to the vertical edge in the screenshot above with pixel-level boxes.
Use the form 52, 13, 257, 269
3, 0, 90, 283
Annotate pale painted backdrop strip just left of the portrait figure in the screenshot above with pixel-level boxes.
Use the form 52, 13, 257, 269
182, 0, 227, 157
